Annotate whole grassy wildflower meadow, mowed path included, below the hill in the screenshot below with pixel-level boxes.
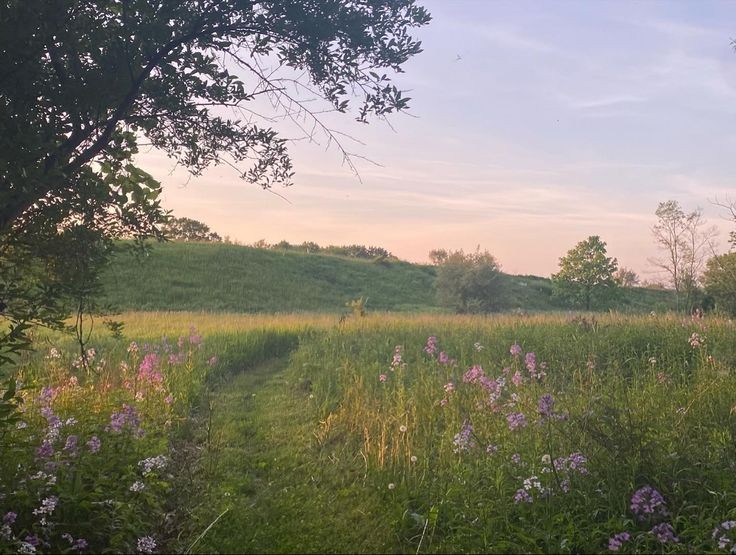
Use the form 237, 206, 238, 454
0, 312, 736, 553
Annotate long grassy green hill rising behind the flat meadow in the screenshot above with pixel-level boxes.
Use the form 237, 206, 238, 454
103, 242, 672, 312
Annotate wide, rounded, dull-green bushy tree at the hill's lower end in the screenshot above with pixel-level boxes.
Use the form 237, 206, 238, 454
436, 249, 502, 313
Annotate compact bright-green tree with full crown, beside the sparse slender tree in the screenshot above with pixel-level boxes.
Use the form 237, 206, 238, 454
552, 235, 618, 310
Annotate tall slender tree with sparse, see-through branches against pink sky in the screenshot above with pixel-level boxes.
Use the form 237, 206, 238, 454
650, 200, 717, 310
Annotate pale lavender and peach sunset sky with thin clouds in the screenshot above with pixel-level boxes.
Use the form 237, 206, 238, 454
139, 0, 736, 281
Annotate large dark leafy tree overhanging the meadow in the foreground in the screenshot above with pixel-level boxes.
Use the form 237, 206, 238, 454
0, 0, 430, 370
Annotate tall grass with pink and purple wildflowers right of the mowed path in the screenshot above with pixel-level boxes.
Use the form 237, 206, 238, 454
293, 316, 736, 553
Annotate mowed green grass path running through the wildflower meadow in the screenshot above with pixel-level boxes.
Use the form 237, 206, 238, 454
193, 358, 400, 553
